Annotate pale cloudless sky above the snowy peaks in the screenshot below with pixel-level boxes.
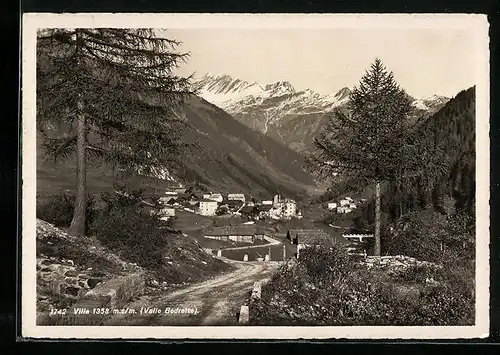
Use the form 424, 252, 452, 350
164, 28, 480, 97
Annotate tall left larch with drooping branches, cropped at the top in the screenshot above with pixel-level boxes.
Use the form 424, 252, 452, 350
37, 28, 191, 236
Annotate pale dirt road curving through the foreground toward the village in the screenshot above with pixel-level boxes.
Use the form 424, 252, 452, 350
105, 258, 278, 326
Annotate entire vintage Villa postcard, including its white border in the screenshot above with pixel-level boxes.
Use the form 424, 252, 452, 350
22, 14, 490, 339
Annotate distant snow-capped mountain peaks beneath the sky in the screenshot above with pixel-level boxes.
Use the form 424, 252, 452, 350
193, 73, 450, 152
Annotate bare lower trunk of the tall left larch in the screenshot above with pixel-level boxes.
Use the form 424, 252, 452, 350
69, 102, 87, 236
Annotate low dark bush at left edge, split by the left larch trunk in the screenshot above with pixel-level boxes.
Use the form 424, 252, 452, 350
36, 193, 96, 231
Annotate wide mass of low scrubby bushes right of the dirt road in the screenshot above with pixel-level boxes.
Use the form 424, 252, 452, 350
251, 241, 475, 326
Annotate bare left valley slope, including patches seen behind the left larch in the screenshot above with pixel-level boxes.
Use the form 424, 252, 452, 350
37, 96, 316, 197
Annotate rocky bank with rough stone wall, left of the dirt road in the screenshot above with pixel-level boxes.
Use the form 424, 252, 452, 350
36, 220, 145, 325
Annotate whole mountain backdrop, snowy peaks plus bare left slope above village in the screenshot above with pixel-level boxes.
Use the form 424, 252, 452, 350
37, 68, 460, 202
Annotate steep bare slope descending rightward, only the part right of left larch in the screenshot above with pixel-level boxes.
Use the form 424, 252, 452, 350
180, 97, 315, 197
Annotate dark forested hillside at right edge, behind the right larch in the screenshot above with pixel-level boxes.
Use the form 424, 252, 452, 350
346, 87, 476, 236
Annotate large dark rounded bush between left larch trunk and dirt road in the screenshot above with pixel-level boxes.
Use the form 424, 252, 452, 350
92, 193, 169, 270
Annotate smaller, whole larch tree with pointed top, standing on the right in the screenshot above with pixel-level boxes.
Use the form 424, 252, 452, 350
313, 59, 442, 256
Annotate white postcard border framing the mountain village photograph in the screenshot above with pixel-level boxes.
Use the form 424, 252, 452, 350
20, 13, 490, 339
